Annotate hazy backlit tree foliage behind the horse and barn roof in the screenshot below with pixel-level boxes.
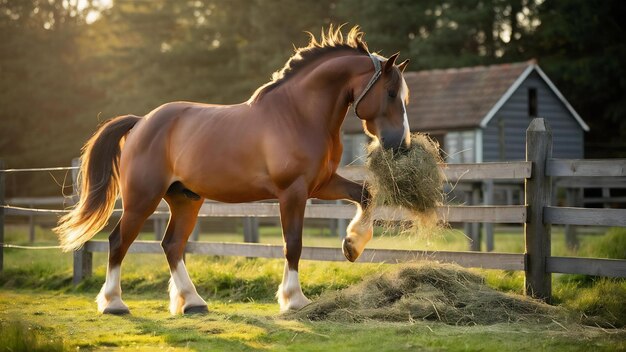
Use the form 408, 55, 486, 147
0, 0, 626, 195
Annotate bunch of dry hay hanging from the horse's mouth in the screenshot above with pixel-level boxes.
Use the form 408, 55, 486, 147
367, 133, 445, 229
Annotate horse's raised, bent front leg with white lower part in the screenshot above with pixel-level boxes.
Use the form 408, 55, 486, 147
314, 174, 374, 262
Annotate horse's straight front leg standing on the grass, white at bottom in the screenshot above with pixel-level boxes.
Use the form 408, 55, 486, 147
276, 179, 311, 312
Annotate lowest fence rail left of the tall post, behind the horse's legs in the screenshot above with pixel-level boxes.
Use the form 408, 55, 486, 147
85, 241, 524, 270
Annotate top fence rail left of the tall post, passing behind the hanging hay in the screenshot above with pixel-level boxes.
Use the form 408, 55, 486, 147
337, 161, 532, 182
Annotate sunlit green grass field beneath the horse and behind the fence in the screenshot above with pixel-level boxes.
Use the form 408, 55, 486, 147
0, 226, 626, 351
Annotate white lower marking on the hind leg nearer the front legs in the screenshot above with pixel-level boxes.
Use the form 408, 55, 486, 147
169, 260, 207, 315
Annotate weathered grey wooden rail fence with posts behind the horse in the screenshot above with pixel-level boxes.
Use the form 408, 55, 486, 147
0, 119, 626, 301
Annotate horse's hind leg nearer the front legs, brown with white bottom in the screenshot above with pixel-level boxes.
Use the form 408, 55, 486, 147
161, 186, 208, 314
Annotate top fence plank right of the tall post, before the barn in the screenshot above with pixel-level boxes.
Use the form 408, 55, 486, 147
546, 159, 626, 177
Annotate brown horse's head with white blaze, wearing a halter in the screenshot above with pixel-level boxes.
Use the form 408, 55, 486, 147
354, 54, 411, 150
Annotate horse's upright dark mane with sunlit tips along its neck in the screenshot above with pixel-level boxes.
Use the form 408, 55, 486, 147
248, 25, 369, 103
